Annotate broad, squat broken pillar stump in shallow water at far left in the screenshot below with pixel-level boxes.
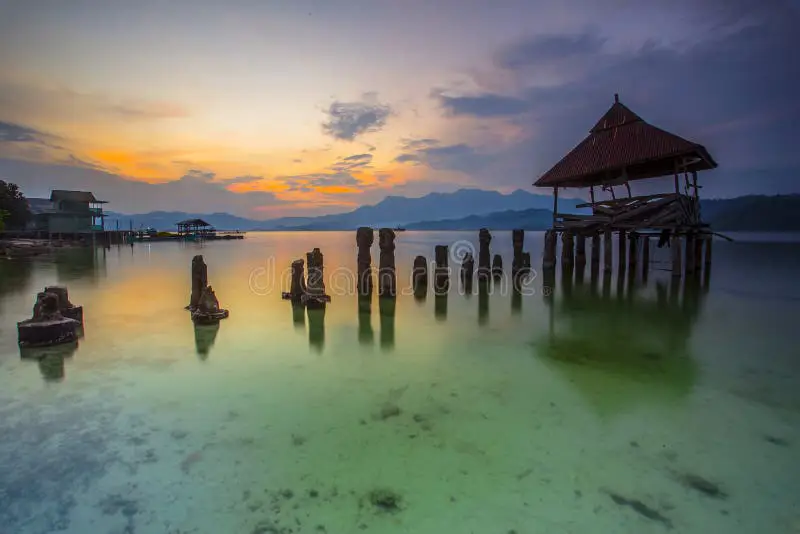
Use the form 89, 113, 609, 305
17, 292, 80, 347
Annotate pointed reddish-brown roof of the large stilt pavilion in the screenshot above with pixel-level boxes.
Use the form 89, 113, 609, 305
533, 95, 717, 187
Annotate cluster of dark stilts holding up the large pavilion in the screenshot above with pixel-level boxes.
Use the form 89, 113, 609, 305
542, 229, 713, 278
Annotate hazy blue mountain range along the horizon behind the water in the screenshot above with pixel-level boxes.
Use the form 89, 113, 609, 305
106, 193, 800, 232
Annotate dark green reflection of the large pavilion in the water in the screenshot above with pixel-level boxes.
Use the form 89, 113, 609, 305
537, 270, 707, 413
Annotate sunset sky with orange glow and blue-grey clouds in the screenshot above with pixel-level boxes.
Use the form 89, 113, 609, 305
0, 0, 800, 219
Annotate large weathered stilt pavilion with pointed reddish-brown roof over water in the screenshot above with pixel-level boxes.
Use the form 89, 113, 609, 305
533, 95, 717, 275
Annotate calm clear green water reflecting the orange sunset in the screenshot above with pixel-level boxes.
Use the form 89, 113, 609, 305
0, 232, 800, 534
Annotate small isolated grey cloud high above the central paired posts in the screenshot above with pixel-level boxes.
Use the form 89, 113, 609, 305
322, 93, 392, 141
